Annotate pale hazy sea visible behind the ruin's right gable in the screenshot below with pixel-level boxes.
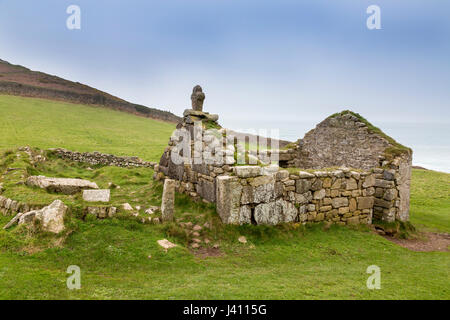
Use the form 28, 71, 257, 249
221, 119, 450, 173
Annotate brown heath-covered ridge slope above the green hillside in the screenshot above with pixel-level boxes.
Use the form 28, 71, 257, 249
0, 60, 180, 122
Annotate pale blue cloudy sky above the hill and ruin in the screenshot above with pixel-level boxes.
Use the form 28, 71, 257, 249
0, 0, 450, 124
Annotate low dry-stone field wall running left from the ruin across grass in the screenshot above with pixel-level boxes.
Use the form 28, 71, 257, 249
50, 148, 156, 168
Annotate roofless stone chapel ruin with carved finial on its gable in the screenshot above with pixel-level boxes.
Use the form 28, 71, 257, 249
154, 86, 412, 225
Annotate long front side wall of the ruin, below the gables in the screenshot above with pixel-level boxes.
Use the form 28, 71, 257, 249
216, 159, 407, 225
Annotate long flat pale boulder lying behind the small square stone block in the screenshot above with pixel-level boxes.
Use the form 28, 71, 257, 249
26, 176, 98, 194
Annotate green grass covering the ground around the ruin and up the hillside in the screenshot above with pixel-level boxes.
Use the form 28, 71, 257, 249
0, 96, 450, 299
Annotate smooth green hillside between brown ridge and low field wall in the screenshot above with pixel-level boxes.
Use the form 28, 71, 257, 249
0, 95, 175, 161
